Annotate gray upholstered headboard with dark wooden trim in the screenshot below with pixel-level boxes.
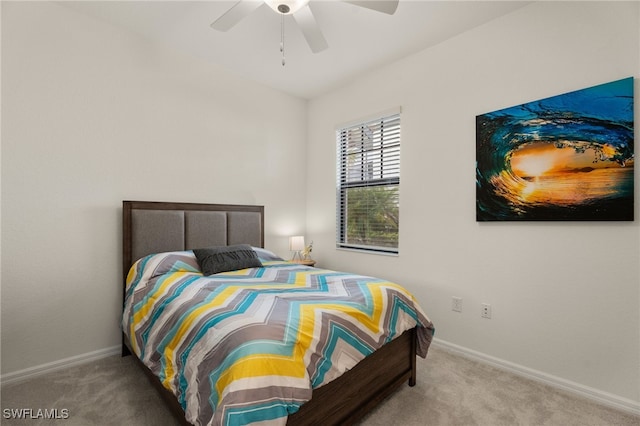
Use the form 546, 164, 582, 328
122, 201, 264, 279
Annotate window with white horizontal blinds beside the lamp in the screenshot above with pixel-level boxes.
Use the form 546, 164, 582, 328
336, 112, 400, 253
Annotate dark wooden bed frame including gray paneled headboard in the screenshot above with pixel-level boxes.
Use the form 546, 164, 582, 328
122, 201, 417, 425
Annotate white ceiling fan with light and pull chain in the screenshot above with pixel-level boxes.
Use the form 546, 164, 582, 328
211, 0, 399, 55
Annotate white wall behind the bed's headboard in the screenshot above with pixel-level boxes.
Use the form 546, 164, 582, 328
1, 2, 306, 374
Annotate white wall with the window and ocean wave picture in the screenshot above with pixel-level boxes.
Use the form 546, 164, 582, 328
307, 2, 640, 407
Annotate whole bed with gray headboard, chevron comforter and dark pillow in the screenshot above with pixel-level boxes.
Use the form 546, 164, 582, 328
122, 201, 433, 425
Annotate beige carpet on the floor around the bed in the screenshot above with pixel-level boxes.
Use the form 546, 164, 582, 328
0, 348, 640, 426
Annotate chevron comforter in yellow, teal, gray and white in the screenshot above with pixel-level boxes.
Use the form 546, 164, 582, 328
122, 251, 433, 425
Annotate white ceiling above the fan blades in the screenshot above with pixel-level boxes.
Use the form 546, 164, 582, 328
60, 0, 530, 99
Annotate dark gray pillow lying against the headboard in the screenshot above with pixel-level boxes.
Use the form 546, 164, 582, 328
193, 244, 262, 275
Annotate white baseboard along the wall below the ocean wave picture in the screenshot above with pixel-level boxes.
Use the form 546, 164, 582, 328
433, 338, 640, 416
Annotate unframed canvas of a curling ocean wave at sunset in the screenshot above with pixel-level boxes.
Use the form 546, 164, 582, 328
476, 77, 635, 222
